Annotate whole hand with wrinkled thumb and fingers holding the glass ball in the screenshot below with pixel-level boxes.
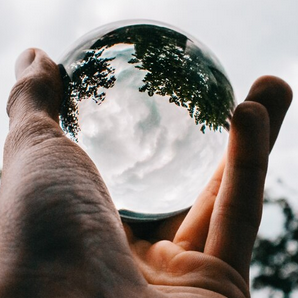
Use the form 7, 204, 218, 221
0, 49, 292, 298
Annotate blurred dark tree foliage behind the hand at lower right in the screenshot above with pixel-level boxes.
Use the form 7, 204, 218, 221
252, 198, 298, 298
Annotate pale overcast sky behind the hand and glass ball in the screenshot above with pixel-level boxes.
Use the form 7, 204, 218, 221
0, 0, 298, 297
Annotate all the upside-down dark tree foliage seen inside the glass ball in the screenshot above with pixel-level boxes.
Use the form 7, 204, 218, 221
61, 25, 234, 138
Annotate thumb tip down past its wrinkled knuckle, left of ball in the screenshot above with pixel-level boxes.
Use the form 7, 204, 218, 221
7, 49, 63, 122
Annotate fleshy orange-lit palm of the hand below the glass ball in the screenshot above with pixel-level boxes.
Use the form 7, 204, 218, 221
127, 240, 249, 298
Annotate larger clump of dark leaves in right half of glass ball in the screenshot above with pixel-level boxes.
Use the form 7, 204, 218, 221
124, 26, 234, 132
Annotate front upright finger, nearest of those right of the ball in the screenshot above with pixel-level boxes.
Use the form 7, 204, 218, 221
204, 102, 269, 280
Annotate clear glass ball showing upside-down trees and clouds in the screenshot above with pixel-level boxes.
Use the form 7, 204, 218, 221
60, 21, 234, 220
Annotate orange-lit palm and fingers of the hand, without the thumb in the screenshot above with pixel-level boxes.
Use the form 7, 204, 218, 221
126, 71, 292, 297
